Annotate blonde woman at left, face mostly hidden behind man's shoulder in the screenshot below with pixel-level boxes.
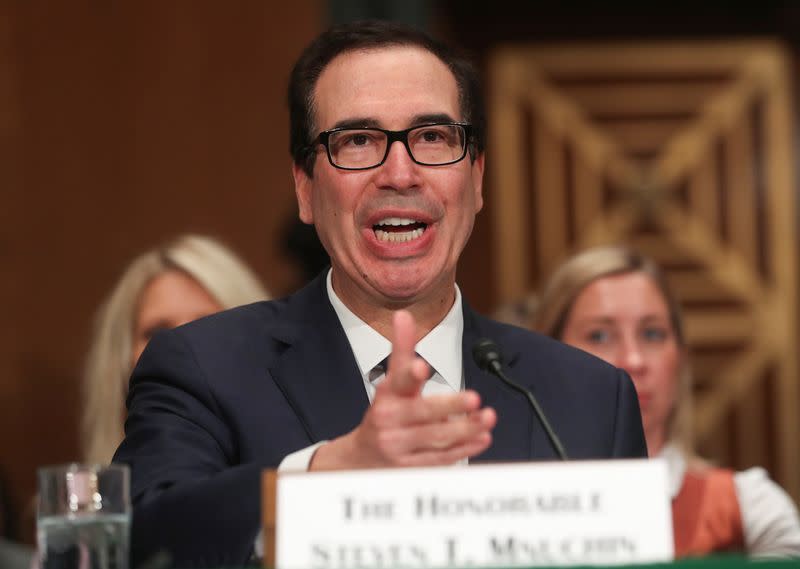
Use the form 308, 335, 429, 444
81, 235, 268, 463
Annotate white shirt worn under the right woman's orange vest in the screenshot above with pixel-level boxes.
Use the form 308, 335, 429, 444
659, 444, 800, 557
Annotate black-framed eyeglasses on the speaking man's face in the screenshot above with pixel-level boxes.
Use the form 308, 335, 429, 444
316, 123, 472, 170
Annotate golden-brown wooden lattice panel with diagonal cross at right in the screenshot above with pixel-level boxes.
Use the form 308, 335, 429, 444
489, 42, 800, 500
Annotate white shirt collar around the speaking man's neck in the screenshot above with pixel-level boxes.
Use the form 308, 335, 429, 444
326, 270, 464, 391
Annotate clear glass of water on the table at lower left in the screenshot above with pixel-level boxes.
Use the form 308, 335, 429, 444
36, 464, 131, 569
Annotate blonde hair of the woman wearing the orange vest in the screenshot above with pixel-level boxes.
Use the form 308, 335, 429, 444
531, 247, 693, 456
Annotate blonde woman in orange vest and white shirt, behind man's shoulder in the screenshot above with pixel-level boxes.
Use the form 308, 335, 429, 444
533, 247, 800, 557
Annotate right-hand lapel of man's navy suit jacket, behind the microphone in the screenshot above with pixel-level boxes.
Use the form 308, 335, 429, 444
463, 302, 533, 462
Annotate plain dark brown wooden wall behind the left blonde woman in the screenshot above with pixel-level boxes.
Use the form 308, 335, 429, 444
0, 0, 323, 537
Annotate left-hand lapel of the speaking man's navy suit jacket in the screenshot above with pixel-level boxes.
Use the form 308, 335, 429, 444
269, 273, 369, 442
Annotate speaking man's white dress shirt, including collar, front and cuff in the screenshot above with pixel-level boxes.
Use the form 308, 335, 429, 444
278, 271, 464, 472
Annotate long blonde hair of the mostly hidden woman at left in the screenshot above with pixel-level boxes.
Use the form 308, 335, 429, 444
81, 235, 269, 463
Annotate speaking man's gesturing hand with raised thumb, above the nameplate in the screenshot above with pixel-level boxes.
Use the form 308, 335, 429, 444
310, 310, 497, 470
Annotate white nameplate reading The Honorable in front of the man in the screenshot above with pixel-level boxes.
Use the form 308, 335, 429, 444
275, 460, 673, 569
